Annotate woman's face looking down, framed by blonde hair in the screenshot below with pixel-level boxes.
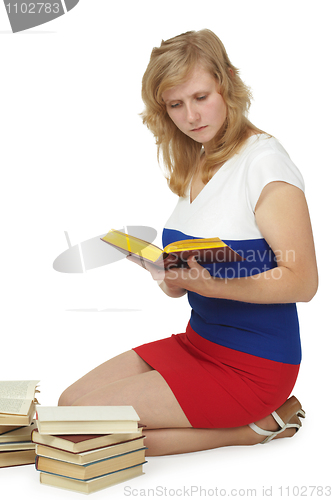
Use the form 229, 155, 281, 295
162, 65, 227, 146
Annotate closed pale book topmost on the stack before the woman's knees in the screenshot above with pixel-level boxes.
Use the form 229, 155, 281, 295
37, 406, 140, 435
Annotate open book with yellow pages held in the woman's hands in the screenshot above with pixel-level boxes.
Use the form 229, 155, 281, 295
101, 229, 244, 269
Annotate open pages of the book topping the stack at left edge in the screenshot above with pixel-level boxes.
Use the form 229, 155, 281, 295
0, 380, 39, 415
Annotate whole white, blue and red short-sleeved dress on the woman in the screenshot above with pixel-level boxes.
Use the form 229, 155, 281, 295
134, 134, 304, 428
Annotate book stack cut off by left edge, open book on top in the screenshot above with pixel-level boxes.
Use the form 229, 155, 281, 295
0, 380, 39, 467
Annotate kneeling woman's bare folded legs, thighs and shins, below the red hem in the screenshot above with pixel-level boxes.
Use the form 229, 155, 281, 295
59, 351, 295, 456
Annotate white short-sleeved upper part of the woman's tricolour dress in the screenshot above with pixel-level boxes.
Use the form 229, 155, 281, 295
165, 134, 304, 240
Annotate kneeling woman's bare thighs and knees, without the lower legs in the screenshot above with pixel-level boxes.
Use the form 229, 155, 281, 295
58, 351, 190, 428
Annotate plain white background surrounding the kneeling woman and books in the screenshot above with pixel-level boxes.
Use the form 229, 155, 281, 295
0, 0, 333, 499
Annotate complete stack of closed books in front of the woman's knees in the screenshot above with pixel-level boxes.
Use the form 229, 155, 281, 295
32, 406, 146, 493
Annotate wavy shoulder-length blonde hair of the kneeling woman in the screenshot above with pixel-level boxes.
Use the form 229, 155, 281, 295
142, 29, 262, 196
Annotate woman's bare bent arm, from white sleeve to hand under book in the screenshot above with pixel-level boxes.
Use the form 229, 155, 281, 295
164, 181, 318, 304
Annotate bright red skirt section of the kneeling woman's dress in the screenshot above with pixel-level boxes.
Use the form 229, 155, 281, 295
133, 324, 299, 429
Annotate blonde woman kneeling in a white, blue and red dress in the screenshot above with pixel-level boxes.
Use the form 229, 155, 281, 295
59, 30, 317, 455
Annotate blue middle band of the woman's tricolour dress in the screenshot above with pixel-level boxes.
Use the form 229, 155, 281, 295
163, 229, 301, 364
